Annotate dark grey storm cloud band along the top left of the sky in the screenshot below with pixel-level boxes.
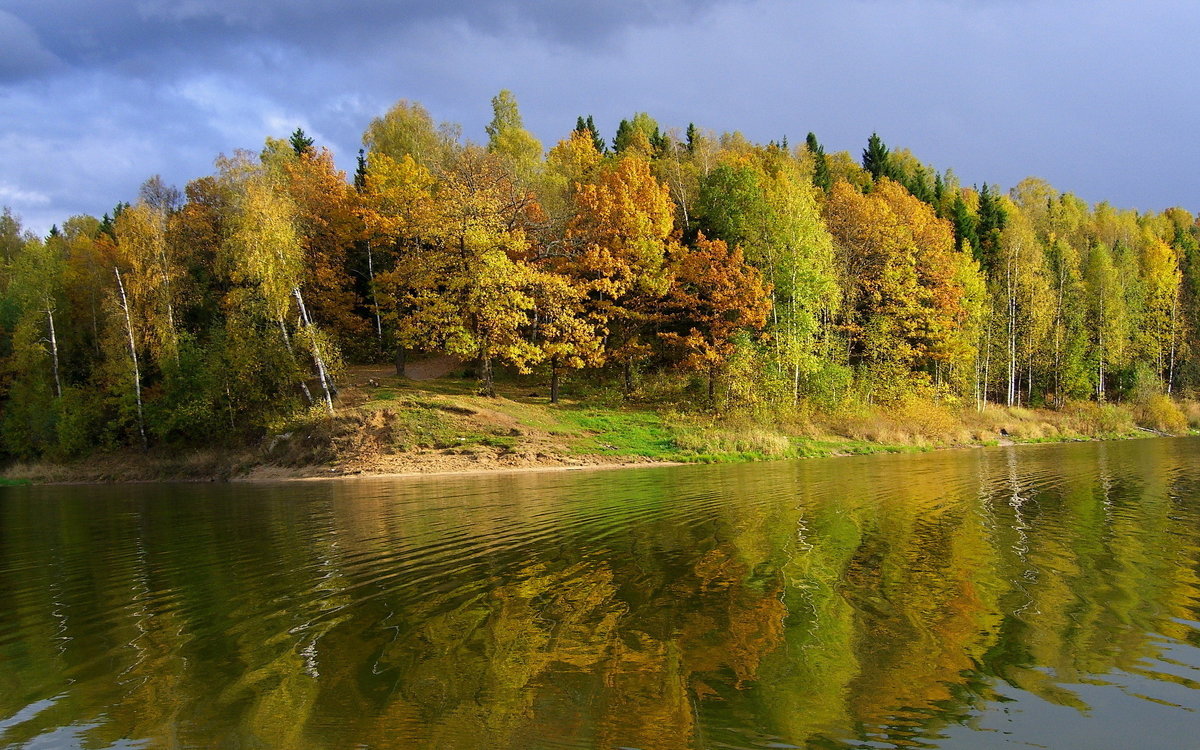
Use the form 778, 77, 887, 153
0, 0, 729, 76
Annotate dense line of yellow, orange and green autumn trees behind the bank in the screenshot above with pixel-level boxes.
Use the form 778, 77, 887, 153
0, 91, 1200, 457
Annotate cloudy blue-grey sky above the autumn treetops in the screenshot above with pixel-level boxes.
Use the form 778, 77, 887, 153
0, 0, 1200, 233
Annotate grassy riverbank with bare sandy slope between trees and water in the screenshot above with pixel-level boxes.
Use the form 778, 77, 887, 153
2, 370, 1200, 484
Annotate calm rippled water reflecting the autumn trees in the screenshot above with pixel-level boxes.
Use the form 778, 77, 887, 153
0, 439, 1200, 750
